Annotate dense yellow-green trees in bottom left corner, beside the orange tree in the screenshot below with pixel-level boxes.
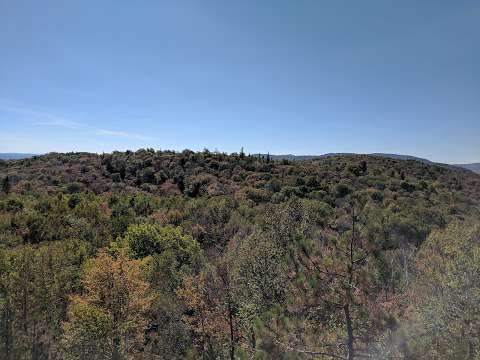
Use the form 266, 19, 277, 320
0, 240, 87, 360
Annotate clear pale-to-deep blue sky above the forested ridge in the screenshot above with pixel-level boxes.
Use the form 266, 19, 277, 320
0, 0, 480, 163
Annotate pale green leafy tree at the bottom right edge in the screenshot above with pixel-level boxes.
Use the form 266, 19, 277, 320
410, 223, 480, 359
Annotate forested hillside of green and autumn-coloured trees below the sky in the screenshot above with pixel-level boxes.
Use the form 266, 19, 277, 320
0, 149, 480, 360
